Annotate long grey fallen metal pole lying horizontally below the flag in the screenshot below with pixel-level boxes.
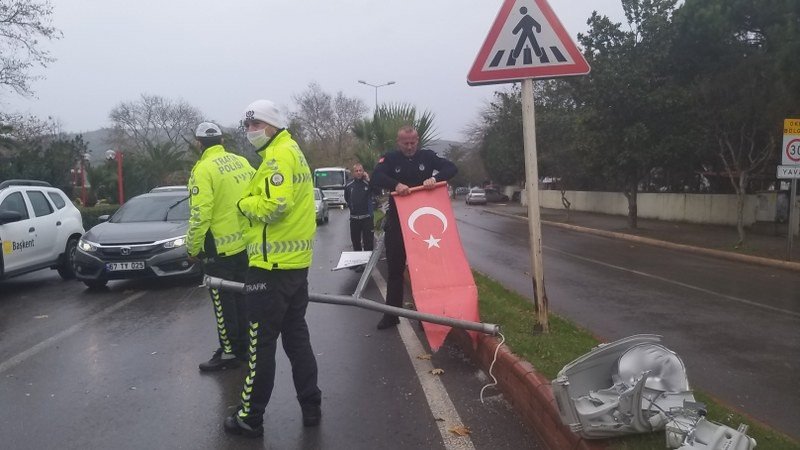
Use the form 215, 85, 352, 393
203, 275, 500, 336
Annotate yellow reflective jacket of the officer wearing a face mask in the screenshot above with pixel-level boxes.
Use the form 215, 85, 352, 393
238, 130, 317, 270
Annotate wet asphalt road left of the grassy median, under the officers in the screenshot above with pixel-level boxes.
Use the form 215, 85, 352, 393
0, 210, 538, 449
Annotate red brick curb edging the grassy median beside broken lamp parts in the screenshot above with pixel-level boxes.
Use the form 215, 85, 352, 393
450, 329, 607, 450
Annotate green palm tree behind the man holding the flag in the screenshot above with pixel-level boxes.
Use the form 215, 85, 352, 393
353, 104, 436, 170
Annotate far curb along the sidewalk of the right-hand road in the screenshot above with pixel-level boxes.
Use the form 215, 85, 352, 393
484, 209, 800, 272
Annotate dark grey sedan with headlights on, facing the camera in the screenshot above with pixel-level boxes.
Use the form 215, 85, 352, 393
75, 187, 201, 288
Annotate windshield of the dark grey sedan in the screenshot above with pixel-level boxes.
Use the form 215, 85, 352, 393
109, 193, 189, 223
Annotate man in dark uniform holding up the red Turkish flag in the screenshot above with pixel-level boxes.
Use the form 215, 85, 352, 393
372, 126, 458, 330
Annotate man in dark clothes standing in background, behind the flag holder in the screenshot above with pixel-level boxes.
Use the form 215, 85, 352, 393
344, 164, 375, 252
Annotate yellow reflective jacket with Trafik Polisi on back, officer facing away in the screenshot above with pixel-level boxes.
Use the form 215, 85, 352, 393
186, 145, 255, 257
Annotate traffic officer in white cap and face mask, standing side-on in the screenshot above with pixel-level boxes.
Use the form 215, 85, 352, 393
224, 100, 322, 437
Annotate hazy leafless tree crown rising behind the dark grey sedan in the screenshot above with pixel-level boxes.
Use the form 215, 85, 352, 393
109, 94, 203, 152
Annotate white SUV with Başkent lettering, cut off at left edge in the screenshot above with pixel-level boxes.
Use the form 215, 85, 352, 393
0, 180, 84, 280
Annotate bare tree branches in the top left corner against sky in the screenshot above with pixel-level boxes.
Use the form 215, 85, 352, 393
0, 0, 62, 96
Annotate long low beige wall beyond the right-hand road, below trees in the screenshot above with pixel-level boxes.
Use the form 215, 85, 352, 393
520, 190, 800, 232
